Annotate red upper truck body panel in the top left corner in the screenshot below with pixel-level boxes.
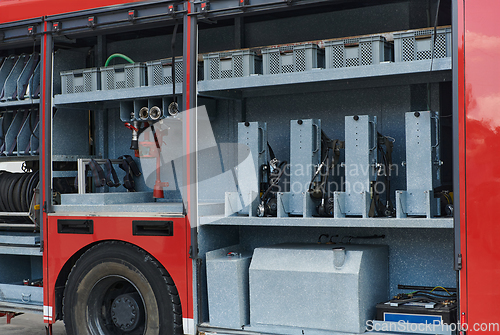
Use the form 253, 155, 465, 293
0, 0, 145, 23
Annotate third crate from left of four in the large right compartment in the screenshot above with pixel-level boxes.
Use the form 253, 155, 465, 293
325, 36, 392, 69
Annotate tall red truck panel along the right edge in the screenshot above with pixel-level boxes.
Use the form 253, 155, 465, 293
462, 0, 500, 332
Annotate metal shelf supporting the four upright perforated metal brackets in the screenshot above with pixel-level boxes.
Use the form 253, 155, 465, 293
200, 216, 453, 229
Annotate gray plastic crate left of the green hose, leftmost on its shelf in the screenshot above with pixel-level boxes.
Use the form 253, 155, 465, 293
61, 68, 99, 94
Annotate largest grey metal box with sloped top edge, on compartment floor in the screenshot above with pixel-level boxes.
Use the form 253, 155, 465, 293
249, 244, 388, 333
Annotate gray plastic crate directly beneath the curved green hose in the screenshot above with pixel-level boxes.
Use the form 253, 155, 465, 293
101, 63, 146, 91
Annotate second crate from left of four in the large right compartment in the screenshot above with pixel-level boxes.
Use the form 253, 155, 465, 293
262, 44, 324, 74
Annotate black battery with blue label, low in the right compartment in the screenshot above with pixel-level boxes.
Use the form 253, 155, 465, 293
377, 300, 457, 325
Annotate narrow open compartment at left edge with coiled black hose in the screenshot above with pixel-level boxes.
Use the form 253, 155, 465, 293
0, 42, 43, 313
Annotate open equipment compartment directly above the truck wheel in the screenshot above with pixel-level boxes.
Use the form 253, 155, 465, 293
53, 31, 187, 215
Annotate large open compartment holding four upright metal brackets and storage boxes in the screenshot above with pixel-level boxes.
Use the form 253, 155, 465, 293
197, 1, 458, 334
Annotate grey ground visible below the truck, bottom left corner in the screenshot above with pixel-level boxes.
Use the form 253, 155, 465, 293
0, 314, 66, 335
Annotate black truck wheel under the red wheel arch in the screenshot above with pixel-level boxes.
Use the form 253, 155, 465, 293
63, 241, 183, 335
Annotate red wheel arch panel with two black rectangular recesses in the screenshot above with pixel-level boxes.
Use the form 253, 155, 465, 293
44, 216, 193, 323
